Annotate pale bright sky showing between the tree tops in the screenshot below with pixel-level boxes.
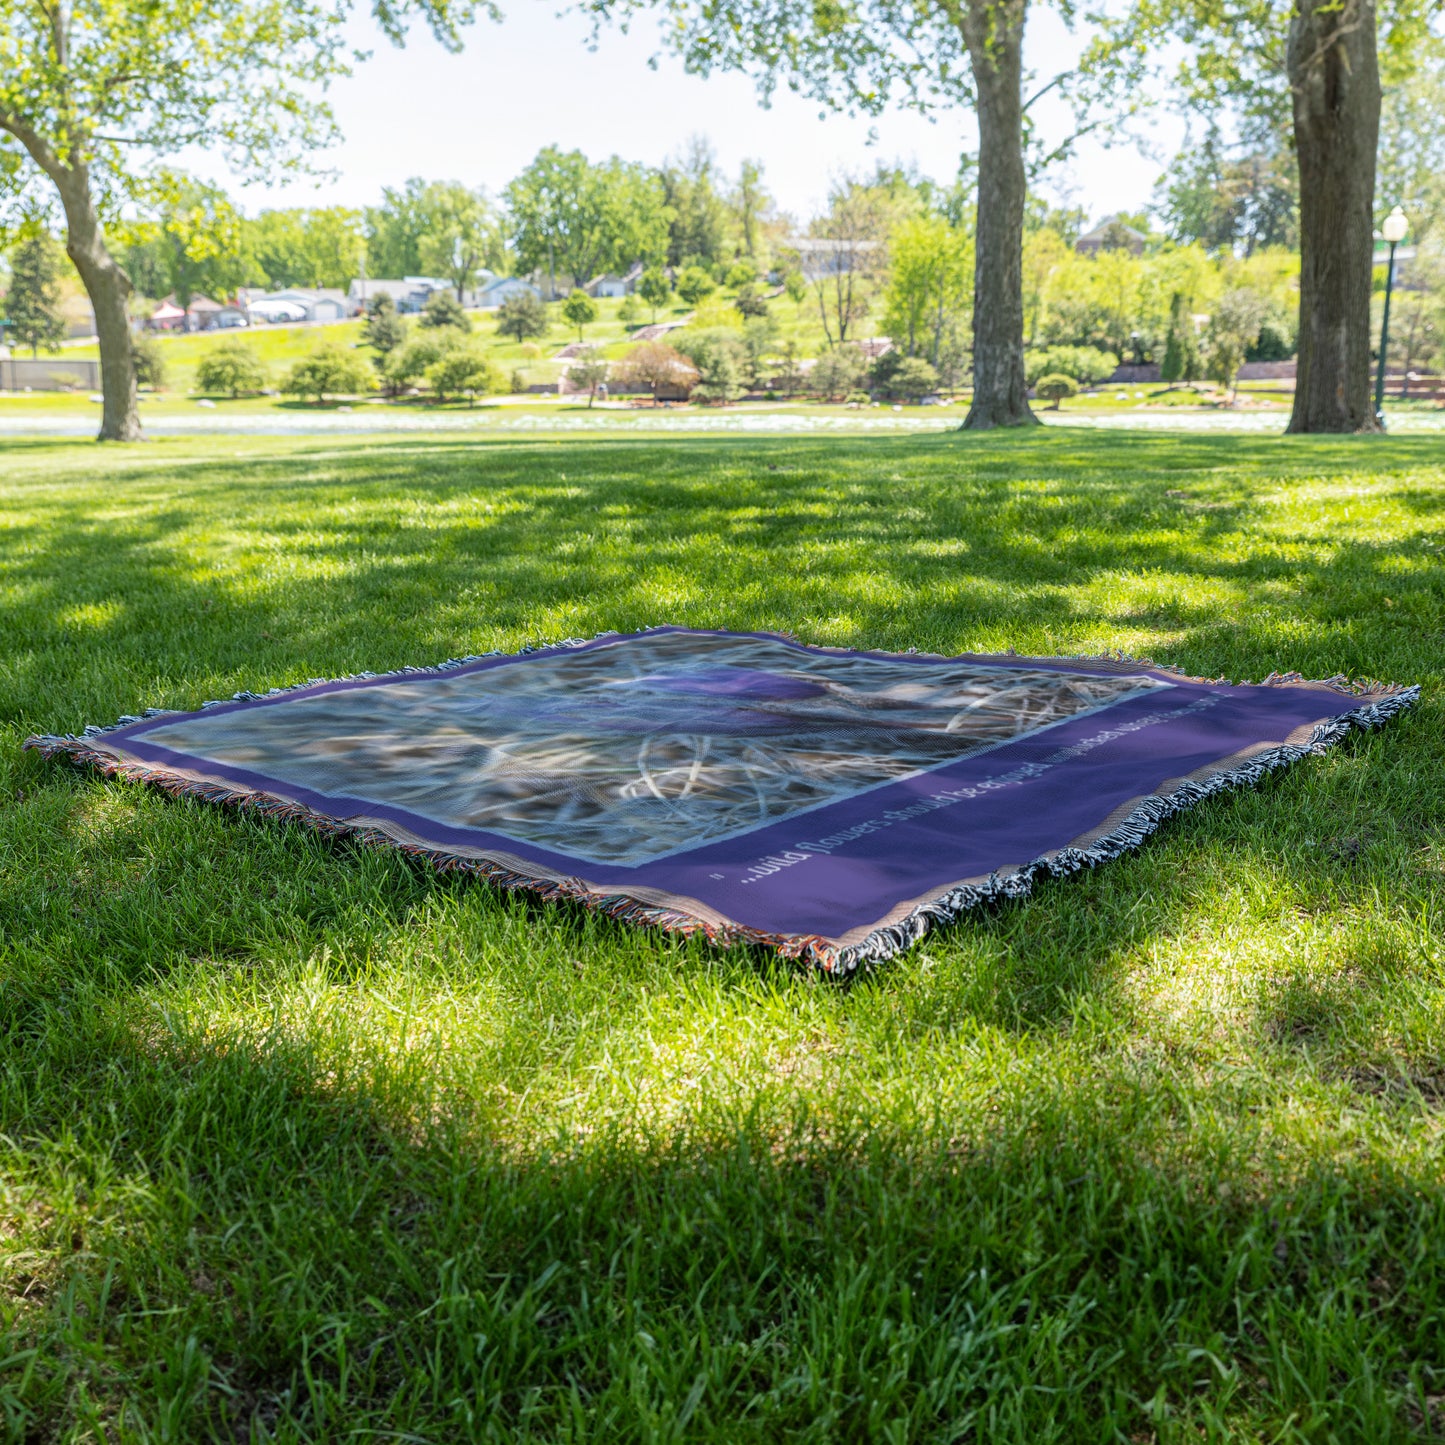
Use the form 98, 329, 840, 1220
216, 0, 1182, 220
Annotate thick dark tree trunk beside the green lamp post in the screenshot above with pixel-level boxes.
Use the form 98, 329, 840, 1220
1286, 0, 1380, 432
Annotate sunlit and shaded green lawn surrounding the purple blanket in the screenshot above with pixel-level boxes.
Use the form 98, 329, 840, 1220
0, 431, 1445, 1445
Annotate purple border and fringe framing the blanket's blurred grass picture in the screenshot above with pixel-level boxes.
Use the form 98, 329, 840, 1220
25, 626, 1419, 974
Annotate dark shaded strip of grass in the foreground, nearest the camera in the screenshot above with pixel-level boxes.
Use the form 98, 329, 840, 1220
0, 965, 1445, 1441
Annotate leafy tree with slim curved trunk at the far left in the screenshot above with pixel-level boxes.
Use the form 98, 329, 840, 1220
0, 0, 490, 439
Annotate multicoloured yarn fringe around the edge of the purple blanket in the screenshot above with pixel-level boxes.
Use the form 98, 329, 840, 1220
23, 629, 1420, 977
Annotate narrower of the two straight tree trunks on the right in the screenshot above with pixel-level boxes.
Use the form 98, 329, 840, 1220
962, 0, 1038, 431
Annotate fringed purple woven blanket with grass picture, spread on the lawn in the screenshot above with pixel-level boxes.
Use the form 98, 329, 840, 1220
26, 627, 1419, 972
